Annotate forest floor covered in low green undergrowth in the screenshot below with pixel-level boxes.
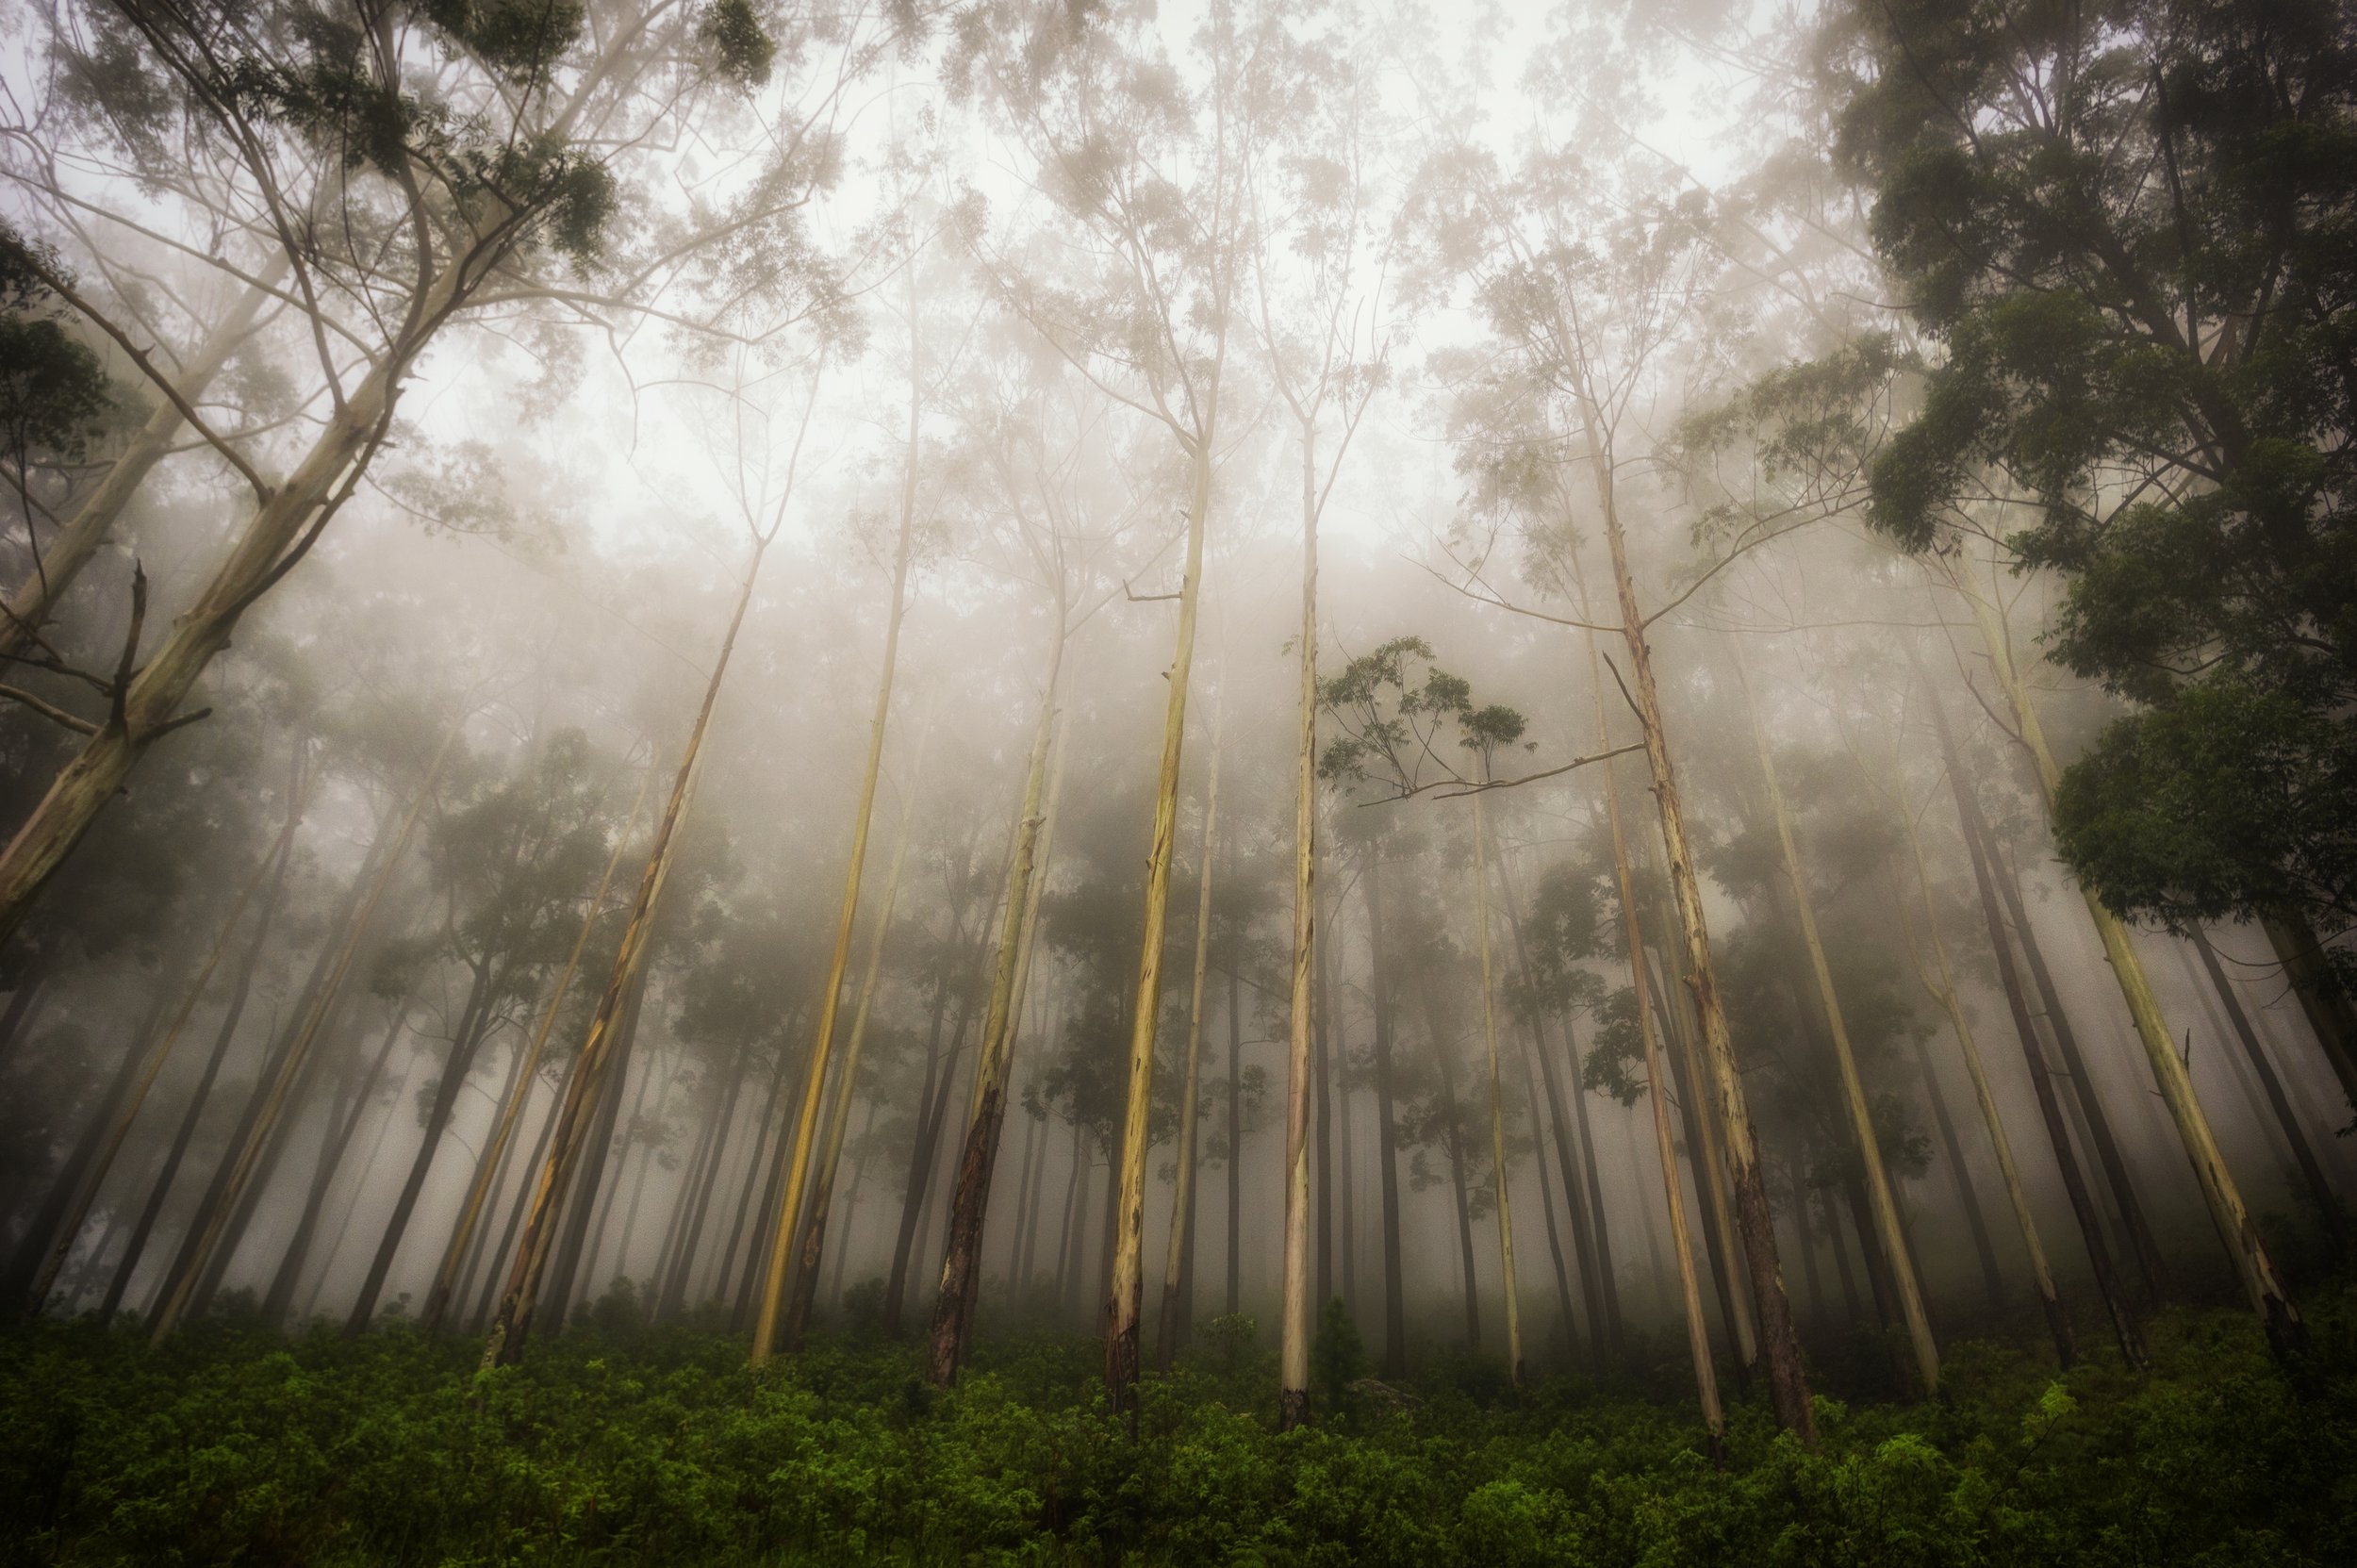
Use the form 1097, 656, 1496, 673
0, 1290, 2357, 1568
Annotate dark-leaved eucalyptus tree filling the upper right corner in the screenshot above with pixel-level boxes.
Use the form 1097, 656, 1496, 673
1822, 0, 2357, 1127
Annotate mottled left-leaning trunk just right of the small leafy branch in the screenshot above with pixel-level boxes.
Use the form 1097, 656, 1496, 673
1584, 445, 1818, 1447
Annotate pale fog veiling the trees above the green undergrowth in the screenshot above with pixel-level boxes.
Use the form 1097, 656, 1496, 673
0, 0, 2352, 1410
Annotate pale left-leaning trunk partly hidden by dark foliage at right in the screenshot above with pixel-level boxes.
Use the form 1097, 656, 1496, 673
1942, 556, 2308, 1356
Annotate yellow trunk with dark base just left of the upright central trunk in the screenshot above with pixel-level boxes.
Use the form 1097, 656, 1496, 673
1106, 436, 1235, 1412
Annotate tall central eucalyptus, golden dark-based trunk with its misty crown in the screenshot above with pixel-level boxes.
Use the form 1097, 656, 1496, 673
946, 0, 1259, 1408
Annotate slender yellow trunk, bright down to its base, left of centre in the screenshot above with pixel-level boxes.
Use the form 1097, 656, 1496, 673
752, 322, 924, 1367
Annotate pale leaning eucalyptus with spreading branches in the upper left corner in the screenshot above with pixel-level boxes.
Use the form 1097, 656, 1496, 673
0, 0, 877, 933
